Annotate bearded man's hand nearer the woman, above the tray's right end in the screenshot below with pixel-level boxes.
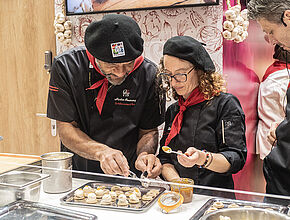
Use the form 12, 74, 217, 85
135, 152, 162, 178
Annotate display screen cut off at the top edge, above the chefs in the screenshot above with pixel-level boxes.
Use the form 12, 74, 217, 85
66, 0, 219, 15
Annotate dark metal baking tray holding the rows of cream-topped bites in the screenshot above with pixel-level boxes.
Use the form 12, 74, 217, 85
60, 182, 165, 212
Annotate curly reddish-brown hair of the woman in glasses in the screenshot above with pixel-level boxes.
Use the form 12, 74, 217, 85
157, 57, 226, 100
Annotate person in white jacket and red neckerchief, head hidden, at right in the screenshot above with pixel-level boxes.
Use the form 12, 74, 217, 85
256, 45, 290, 160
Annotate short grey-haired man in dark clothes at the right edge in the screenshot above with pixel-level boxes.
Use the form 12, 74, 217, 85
248, 0, 290, 200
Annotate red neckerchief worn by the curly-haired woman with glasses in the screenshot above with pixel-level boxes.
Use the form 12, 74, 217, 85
165, 87, 205, 146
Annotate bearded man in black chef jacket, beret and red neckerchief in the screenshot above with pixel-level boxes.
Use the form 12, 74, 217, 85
47, 14, 164, 177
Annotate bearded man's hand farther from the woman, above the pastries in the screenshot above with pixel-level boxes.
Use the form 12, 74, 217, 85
97, 147, 129, 176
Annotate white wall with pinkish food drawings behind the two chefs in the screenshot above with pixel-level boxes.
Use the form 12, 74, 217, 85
55, 0, 223, 72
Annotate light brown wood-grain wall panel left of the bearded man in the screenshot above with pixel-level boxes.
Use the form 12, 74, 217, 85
0, 0, 59, 155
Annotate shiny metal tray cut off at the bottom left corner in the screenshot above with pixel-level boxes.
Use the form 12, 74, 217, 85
0, 200, 97, 220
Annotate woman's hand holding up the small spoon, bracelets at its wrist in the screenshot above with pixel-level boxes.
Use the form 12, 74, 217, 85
177, 147, 206, 167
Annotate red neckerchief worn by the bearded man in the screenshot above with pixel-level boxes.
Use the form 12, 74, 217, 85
86, 50, 144, 114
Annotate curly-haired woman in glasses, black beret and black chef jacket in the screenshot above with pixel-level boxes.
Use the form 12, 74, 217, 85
159, 36, 247, 196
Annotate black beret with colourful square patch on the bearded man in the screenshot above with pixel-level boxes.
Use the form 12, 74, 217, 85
85, 14, 144, 63
